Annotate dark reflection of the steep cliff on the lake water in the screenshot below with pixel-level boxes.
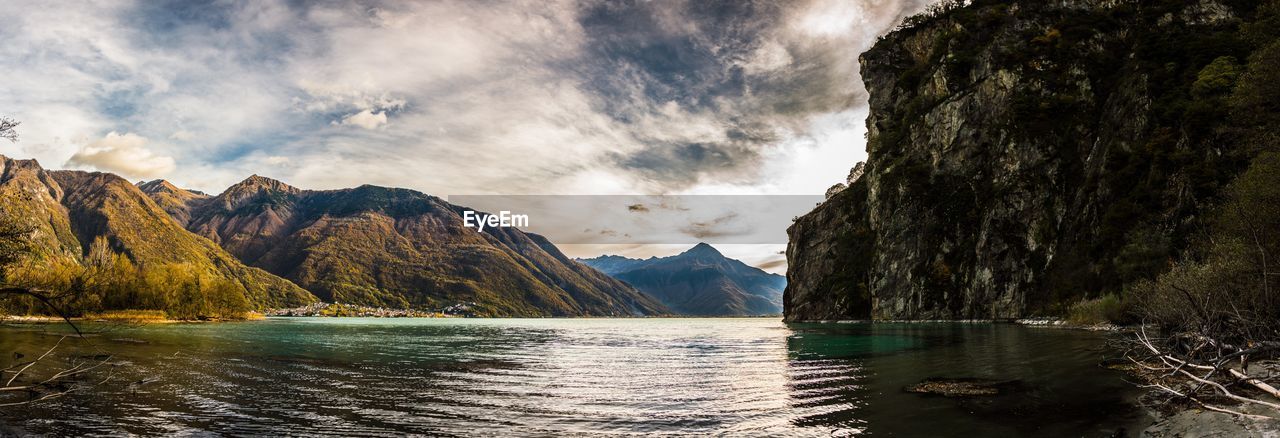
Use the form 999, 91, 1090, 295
787, 323, 1140, 437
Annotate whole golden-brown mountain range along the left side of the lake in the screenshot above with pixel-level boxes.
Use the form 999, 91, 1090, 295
0, 156, 669, 316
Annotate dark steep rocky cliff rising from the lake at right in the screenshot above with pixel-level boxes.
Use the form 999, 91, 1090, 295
786, 0, 1254, 320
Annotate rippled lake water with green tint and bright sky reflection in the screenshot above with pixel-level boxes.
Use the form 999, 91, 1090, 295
0, 318, 1138, 437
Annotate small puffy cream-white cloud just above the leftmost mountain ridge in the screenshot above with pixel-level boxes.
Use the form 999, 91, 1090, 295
67, 132, 174, 178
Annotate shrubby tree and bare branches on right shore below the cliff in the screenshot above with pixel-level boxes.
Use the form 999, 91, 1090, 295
1125, 152, 1280, 418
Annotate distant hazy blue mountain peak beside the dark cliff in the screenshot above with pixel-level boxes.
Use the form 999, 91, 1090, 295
580, 243, 786, 316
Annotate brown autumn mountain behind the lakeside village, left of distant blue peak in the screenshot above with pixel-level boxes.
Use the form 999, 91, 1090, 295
162, 175, 667, 316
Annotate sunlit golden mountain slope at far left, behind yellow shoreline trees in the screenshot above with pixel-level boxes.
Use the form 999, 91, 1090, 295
0, 156, 315, 309
